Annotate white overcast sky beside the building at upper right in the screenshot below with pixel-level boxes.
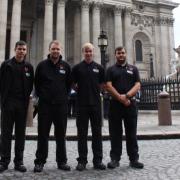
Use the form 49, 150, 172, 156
173, 0, 180, 47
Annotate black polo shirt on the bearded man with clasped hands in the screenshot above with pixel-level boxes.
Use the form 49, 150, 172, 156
106, 63, 140, 94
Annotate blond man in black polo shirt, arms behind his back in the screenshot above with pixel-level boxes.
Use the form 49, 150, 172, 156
72, 43, 106, 171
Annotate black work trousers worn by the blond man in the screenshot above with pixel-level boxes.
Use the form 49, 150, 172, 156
77, 106, 103, 164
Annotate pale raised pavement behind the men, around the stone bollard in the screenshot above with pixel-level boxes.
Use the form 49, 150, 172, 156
26, 110, 180, 139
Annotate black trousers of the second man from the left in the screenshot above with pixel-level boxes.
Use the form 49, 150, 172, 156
34, 102, 67, 164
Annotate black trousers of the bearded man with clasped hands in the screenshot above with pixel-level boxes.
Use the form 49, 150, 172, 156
109, 100, 139, 161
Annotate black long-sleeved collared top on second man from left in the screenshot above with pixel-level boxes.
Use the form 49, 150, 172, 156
35, 56, 71, 104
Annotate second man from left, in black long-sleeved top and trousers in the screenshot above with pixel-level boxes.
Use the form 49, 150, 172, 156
34, 40, 71, 172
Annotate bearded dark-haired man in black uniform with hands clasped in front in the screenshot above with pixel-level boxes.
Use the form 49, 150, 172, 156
106, 47, 143, 169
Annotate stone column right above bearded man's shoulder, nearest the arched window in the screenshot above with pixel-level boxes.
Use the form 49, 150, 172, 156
124, 7, 133, 64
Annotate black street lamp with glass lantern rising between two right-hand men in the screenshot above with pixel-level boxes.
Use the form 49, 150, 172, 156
98, 30, 108, 69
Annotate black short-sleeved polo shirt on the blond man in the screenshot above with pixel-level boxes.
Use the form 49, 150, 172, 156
72, 61, 105, 106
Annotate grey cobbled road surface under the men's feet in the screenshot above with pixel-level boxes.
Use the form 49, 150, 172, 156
0, 139, 180, 180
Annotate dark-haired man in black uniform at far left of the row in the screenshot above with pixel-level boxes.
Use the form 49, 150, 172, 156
0, 41, 34, 172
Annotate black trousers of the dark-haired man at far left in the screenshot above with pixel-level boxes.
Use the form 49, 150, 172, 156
0, 100, 27, 166
